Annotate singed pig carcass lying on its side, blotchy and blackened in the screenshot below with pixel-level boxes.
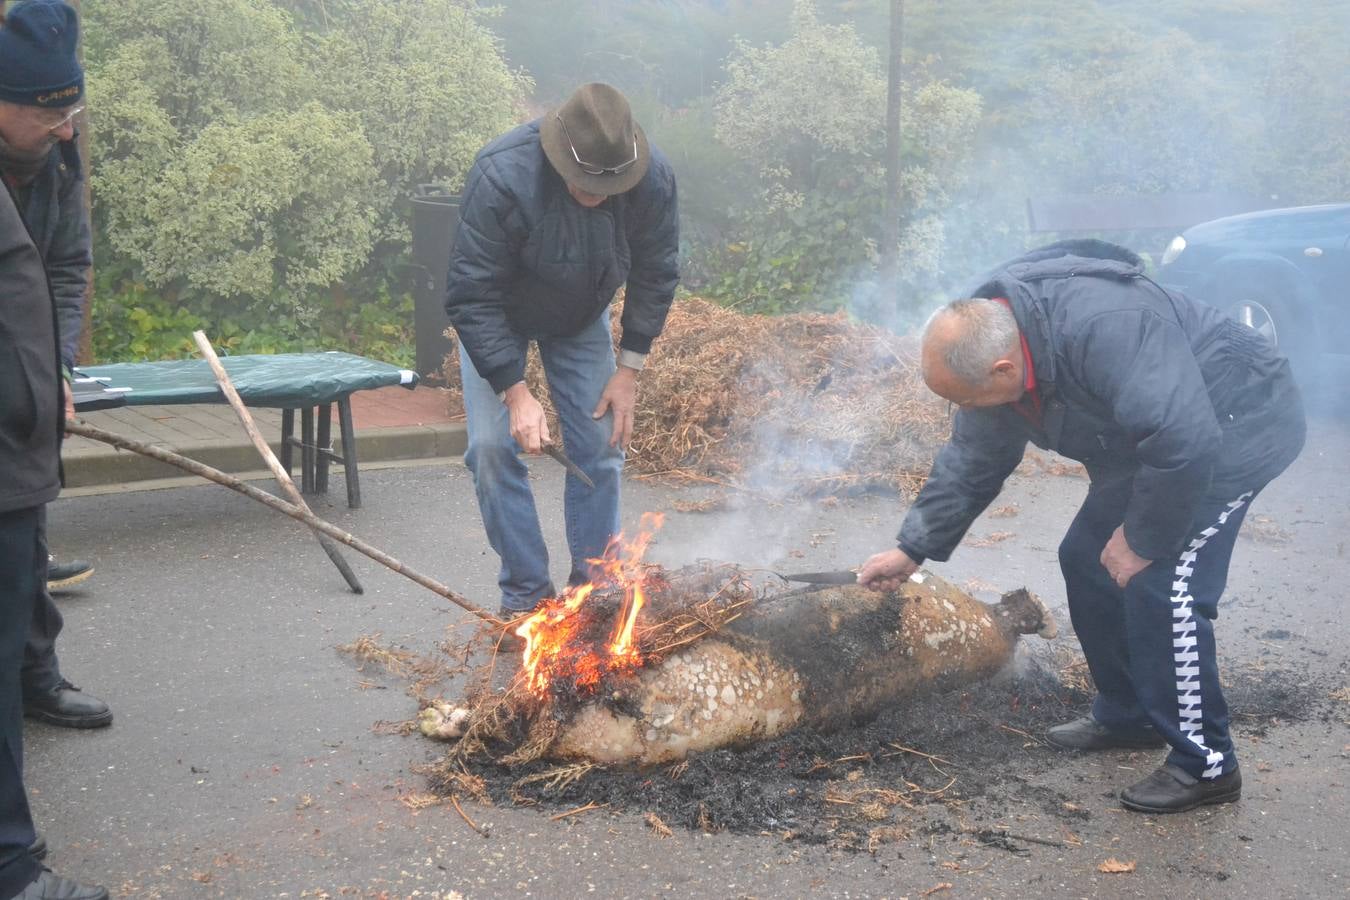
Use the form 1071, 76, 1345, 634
548, 575, 1054, 765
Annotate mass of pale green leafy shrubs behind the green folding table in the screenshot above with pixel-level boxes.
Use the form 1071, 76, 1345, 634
85, 0, 529, 340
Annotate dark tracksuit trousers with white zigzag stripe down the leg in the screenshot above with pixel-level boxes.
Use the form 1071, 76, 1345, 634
1060, 478, 1264, 779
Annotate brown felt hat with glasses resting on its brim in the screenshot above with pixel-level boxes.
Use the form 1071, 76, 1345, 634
539, 82, 651, 197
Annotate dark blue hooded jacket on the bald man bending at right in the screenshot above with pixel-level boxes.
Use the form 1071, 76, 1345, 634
898, 240, 1304, 561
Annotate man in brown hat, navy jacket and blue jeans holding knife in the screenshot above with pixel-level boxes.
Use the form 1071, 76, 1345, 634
446, 84, 679, 617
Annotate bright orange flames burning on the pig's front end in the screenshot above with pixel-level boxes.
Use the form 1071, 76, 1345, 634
516, 513, 666, 695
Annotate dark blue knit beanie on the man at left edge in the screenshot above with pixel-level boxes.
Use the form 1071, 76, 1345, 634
0, 0, 84, 107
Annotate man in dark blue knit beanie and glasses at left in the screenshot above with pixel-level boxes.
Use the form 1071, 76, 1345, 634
0, 0, 112, 729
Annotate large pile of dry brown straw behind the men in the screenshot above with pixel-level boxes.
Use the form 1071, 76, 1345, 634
446, 298, 949, 497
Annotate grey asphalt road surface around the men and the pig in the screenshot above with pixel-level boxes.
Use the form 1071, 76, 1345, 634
27, 410, 1350, 897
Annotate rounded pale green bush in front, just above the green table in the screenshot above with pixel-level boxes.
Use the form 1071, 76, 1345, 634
101, 101, 375, 317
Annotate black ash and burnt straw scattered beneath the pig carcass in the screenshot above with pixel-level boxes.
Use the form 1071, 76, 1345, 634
432, 647, 1331, 854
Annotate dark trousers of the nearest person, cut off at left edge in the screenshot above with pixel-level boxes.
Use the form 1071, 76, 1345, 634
0, 506, 47, 897
